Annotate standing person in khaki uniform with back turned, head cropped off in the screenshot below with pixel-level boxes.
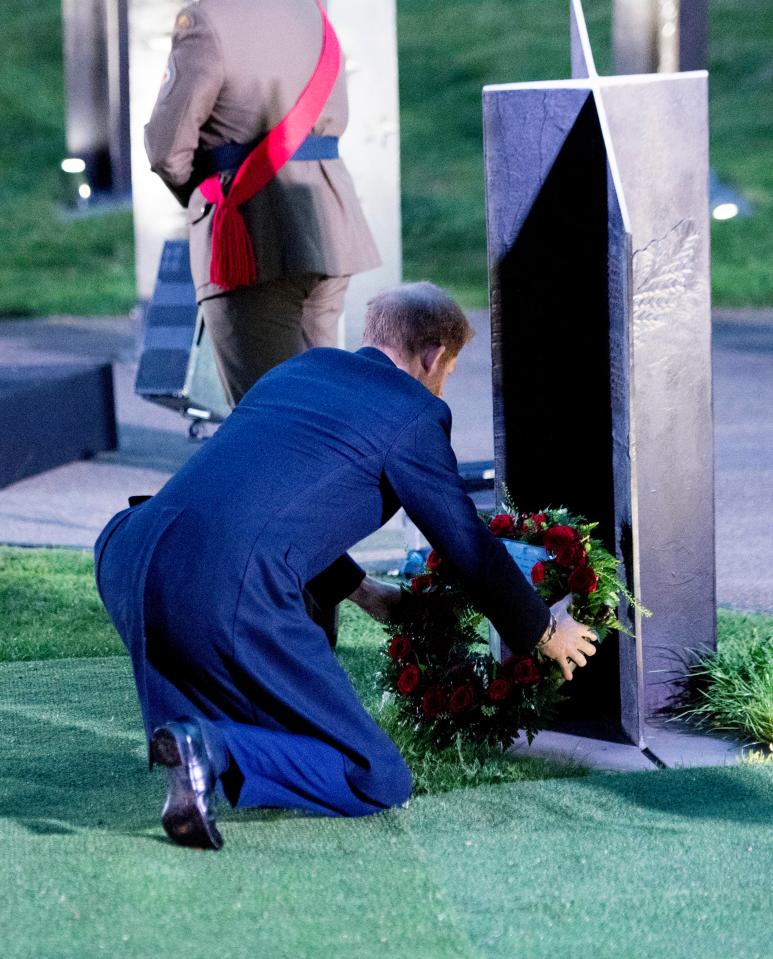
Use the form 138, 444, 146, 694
145, 0, 380, 406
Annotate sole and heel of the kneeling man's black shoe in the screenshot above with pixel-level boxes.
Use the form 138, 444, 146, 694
150, 728, 223, 850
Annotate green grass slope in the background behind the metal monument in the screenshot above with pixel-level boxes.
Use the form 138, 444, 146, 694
0, 0, 773, 316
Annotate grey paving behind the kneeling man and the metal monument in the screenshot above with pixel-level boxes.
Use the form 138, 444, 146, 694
0, 310, 773, 612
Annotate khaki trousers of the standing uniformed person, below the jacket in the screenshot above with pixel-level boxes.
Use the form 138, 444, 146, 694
201, 273, 349, 408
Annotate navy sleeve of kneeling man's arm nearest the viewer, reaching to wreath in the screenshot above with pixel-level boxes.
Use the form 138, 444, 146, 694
384, 400, 550, 652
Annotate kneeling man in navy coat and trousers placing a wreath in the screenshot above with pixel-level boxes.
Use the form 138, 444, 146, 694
95, 283, 594, 849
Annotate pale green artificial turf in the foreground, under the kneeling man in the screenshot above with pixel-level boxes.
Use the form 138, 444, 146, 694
0, 657, 773, 959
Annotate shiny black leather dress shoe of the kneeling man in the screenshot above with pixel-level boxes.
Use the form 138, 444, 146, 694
150, 718, 223, 849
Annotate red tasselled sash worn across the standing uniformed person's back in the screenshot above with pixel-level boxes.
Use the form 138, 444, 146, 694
200, 0, 341, 290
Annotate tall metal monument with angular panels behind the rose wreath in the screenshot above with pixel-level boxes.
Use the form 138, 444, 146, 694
483, 0, 715, 746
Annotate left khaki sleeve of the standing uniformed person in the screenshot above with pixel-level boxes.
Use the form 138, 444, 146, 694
145, 4, 223, 205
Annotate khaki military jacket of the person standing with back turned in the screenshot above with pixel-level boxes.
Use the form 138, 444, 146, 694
145, 0, 380, 300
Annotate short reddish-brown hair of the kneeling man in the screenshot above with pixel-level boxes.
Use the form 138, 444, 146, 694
363, 281, 475, 356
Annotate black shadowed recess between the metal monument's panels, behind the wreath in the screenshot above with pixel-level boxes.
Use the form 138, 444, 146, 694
492, 96, 620, 721
